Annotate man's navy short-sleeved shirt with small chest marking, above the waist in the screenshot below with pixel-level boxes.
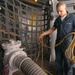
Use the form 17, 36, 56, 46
54, 13, 75, 43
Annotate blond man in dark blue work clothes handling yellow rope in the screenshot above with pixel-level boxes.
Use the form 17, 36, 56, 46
39, 2, 75, 75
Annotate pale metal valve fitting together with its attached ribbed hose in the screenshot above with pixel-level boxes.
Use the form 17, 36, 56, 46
2, 40, 47, 75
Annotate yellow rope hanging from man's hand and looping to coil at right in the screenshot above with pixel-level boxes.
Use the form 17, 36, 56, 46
40, 32, 75, 75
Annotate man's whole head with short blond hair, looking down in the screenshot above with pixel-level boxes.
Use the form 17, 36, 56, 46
56, 2, 67, 17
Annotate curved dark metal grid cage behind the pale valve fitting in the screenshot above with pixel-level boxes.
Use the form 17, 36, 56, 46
0, 0, 50, 61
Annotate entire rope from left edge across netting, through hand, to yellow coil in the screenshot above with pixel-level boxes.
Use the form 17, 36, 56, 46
0, 29, 75, 75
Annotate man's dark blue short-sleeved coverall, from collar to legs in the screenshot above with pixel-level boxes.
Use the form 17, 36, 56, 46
54, 13, 75, 75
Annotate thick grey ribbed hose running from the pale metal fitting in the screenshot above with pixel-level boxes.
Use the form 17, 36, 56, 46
14, 56, 47, 75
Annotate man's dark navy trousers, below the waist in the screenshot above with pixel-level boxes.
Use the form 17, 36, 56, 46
55, 45, 71, 75
